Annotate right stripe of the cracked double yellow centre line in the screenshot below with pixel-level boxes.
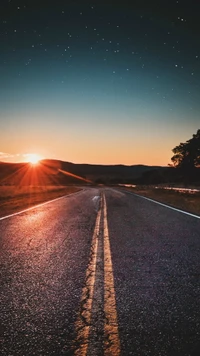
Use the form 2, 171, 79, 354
103, 195, 120, 356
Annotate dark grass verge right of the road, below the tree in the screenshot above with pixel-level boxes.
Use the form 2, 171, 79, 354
123, 186, 200, 215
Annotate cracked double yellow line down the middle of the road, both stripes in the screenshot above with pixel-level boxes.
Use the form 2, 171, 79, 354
74, 194, 120, 356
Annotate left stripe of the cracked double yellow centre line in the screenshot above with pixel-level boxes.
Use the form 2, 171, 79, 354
74, 198, 102, 356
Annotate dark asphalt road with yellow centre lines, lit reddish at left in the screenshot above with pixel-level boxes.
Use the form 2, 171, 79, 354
0, 188, 200, 356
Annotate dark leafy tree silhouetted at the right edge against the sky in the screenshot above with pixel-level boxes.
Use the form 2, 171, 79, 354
171, 129, 200, 172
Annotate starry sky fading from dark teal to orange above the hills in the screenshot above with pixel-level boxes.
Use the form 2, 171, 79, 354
0, 0, 200, 165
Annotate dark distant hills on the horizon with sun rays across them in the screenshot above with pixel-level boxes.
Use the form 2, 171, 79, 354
0, 159, 166, 185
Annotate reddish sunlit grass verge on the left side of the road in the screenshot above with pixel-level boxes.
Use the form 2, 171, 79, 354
0, 185, 82, 217
